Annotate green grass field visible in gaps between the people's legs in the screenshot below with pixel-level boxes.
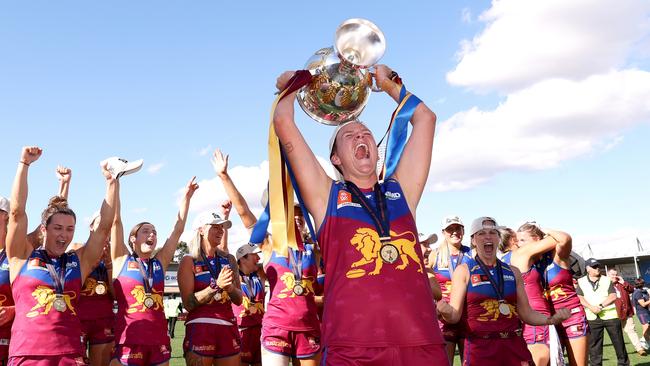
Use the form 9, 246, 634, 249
170, 318, 650, 366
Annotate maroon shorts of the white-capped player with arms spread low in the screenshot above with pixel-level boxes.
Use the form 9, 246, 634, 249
463, 337, 535, 366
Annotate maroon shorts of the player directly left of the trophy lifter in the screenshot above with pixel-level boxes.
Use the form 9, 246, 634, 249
262, 325, 321, 358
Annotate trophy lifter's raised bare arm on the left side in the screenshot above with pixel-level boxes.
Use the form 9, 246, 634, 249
273, 71, 332, 230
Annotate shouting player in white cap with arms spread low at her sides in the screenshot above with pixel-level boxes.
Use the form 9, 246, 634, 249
438, 217, 569, 366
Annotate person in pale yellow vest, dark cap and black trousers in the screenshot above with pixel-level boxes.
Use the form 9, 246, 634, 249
576, 258, 630, 366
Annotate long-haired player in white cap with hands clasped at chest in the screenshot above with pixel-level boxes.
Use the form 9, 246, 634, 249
178, 212, 242, 366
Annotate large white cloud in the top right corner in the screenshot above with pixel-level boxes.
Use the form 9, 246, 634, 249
447, 0, 650, 92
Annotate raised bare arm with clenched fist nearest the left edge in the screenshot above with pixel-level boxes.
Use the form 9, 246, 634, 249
6, 146, 43, 272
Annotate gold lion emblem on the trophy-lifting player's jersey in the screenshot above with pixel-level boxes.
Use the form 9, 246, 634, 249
346, 228, 423, 278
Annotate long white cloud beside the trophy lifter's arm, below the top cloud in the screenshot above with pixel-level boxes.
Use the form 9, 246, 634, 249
429, 70, 650, 191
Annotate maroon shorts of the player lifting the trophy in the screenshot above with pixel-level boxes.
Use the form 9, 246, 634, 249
321, 344, 449, 366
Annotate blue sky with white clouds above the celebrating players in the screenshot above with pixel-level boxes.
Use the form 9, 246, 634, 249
0, 0, 650, 256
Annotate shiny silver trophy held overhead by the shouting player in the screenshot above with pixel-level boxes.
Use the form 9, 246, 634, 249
297, 19, 386, 126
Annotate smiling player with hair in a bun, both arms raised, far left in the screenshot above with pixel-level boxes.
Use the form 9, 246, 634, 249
6, 146, 116, 365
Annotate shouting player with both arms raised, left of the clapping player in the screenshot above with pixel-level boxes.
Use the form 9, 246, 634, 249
110, 169, 199, 366
